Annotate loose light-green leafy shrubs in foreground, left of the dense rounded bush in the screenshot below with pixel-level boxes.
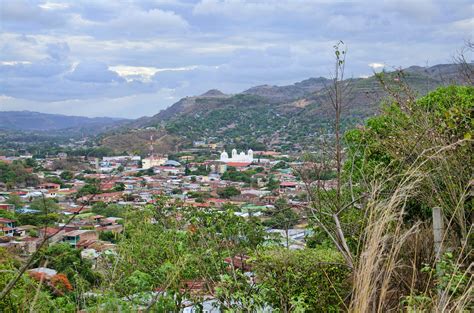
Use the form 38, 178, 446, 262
99, 199, 263, 305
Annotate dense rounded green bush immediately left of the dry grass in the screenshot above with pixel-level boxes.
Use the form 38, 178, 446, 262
253, 249, 350, 312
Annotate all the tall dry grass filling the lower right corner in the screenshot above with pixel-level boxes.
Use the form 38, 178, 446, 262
349, 145, 474, 312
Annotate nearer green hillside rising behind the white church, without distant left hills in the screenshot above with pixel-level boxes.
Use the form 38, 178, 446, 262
103, 65, 466, 152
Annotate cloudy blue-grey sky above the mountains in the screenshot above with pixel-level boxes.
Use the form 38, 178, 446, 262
0, 0, 474, 118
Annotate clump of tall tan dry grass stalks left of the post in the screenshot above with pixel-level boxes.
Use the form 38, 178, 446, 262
350, 172, 421, 312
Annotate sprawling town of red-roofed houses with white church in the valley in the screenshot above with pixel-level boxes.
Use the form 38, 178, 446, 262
0, 138, 335, 308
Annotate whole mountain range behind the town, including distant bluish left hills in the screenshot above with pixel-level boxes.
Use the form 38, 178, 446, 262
0, 64, 470, 153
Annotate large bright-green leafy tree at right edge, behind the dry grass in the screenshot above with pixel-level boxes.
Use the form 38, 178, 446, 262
345, 86, 474, 229
